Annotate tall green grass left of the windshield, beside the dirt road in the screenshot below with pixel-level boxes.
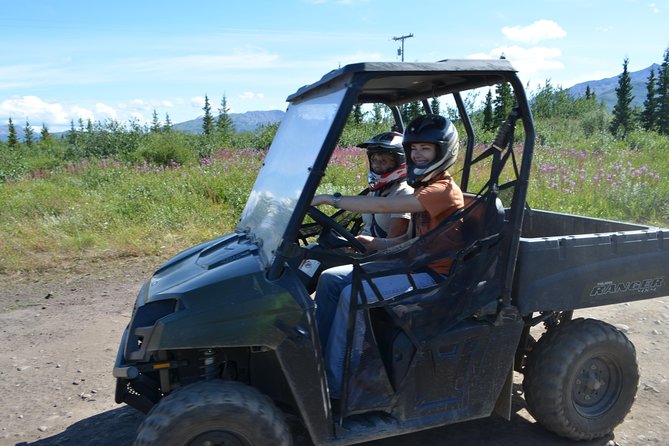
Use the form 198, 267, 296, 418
0, 150, 263, 271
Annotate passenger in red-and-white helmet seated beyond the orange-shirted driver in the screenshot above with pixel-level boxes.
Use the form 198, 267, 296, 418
358, 132, 413, 238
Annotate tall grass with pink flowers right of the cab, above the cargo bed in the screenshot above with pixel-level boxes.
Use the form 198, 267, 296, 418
528, 139, 669, 226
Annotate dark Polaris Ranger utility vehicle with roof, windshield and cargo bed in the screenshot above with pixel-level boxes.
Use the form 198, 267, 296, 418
114, 60, 669, 446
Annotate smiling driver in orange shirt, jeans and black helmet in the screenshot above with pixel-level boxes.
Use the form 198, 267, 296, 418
311, 114, 464, 399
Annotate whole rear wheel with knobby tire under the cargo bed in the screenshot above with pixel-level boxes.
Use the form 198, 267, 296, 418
523, 319, 639, 440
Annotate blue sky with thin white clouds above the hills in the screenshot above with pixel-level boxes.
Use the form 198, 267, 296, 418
0, 0, 669, 131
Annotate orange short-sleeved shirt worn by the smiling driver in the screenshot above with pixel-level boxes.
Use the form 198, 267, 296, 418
412, 172, 465, 274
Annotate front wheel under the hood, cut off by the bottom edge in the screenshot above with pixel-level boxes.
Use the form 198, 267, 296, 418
135, 380, 293, 446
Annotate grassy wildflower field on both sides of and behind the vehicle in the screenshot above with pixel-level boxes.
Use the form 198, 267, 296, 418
0, 139, 669, 272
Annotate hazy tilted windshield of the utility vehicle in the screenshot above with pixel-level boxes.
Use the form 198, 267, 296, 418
237, 89, 346, 266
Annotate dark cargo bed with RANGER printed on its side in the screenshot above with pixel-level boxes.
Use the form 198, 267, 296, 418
512, 210, 669, 315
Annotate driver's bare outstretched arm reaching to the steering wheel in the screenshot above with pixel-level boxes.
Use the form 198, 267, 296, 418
311, 194, 425, 214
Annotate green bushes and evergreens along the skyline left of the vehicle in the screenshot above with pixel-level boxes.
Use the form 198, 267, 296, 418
0, 92, 278, 181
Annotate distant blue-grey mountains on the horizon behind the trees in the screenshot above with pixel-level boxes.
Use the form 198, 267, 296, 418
0, 64, 660, 141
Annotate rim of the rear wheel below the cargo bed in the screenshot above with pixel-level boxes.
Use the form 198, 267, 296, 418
572, 358, 622, 418
